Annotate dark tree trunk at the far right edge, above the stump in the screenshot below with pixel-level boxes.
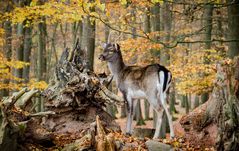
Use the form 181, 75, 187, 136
227, 0, 239, 58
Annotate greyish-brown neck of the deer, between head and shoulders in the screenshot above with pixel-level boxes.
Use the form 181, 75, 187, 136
108, 54, 125, 82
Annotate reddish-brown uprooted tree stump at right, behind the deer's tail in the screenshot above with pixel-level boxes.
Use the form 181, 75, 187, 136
180, 60, 239, 151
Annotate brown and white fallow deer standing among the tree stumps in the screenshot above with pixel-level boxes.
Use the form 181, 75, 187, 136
99, 43, 174, 138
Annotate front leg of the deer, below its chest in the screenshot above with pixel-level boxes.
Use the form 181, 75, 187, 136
125, 96, 134, 135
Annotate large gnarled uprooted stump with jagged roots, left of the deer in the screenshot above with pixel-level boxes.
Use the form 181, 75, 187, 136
0, 39, 122, 150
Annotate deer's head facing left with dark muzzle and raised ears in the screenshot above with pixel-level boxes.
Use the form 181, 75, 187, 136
99, 43, 121, 62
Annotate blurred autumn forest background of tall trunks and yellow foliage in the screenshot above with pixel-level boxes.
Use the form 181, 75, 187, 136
0, 0, 239, 150
